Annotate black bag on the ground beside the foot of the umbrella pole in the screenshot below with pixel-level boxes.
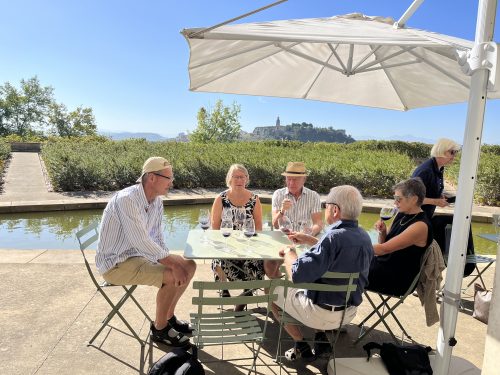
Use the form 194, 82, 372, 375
363, 342, 432, 375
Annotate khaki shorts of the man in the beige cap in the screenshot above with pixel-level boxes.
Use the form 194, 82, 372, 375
102, 257, 165, 288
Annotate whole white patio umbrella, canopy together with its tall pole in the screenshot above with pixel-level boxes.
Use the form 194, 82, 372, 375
182, 0, 500, 374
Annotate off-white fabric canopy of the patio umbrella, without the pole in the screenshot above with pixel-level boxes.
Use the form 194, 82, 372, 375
182, 13, 500, 111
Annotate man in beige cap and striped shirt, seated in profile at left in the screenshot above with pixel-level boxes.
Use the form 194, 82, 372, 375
96, 157, 196, 346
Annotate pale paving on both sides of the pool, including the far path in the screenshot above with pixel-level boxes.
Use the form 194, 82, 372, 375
0, 153, 495, 375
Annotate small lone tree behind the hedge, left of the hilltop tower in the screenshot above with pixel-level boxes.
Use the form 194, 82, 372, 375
189, 99, 241, 143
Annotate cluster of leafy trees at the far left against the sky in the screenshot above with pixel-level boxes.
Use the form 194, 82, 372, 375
0, 76, 97, 138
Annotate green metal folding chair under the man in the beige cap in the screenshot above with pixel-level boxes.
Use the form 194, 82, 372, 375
76, 222, 151, 350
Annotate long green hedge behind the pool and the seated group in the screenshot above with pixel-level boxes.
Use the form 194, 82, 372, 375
42, 137, 500, 206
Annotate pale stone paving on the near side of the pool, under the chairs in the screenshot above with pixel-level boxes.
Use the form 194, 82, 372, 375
0, 250, 494, 375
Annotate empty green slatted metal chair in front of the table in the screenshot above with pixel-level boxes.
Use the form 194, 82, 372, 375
190, 280, 276, 374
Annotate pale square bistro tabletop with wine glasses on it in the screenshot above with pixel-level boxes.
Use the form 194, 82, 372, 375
184, 229, 291, 260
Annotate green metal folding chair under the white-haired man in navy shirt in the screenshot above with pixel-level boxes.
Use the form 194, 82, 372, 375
276, 268, 359, 373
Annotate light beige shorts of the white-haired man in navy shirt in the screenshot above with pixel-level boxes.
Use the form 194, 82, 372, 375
274, 286, 357, 331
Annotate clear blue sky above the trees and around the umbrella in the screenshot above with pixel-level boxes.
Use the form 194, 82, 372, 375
0, 0, 500, 144
